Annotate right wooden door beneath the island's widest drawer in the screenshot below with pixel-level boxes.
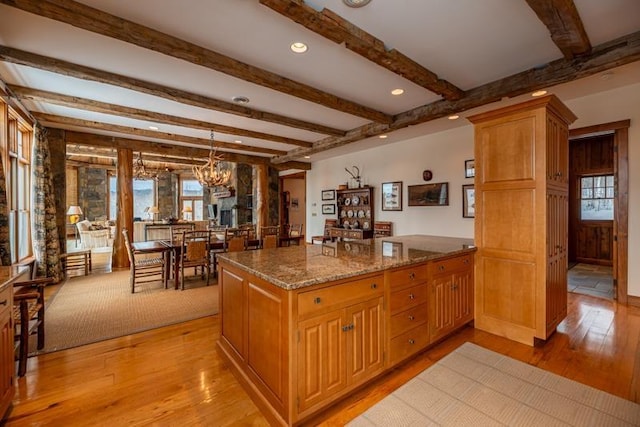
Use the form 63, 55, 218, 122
347, 297, 383, 384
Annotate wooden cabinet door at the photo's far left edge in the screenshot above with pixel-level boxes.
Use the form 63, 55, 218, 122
0, 306, 16, 418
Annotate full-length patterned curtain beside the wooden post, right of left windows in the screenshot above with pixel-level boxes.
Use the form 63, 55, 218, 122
32, 126, 63, 283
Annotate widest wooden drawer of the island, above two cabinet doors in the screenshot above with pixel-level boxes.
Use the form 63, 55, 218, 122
298, 276, 384, 316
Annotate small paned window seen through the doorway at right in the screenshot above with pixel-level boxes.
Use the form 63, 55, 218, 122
580, 175, 614, 221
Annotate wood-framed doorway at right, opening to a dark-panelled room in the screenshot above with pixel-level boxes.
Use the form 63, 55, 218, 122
568, 120, 630, 304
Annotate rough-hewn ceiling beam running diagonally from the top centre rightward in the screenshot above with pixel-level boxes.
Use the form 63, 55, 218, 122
260, 0, 464, 100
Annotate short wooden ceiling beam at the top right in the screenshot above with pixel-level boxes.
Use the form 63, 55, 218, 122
527, 0, 591, 59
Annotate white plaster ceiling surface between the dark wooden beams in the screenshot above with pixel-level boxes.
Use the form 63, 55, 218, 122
0, 0, 640, 167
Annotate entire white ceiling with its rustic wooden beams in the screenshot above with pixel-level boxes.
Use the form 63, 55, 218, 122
0, 0, 640, 170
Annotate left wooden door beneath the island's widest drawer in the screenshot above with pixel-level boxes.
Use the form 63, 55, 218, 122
298, 310, 347, 413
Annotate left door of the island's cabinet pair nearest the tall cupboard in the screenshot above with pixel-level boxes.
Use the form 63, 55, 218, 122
429, 275, 454, 342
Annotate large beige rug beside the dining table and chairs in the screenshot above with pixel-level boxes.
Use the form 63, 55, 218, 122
39, 270, 218, 353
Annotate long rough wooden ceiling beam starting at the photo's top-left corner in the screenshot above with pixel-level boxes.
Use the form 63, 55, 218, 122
0, 0, 393, 123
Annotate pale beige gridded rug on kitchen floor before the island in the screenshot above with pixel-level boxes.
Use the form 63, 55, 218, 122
348, 343, 640, 427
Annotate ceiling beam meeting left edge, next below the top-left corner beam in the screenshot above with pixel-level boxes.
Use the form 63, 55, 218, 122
0, 45, 345, 136
